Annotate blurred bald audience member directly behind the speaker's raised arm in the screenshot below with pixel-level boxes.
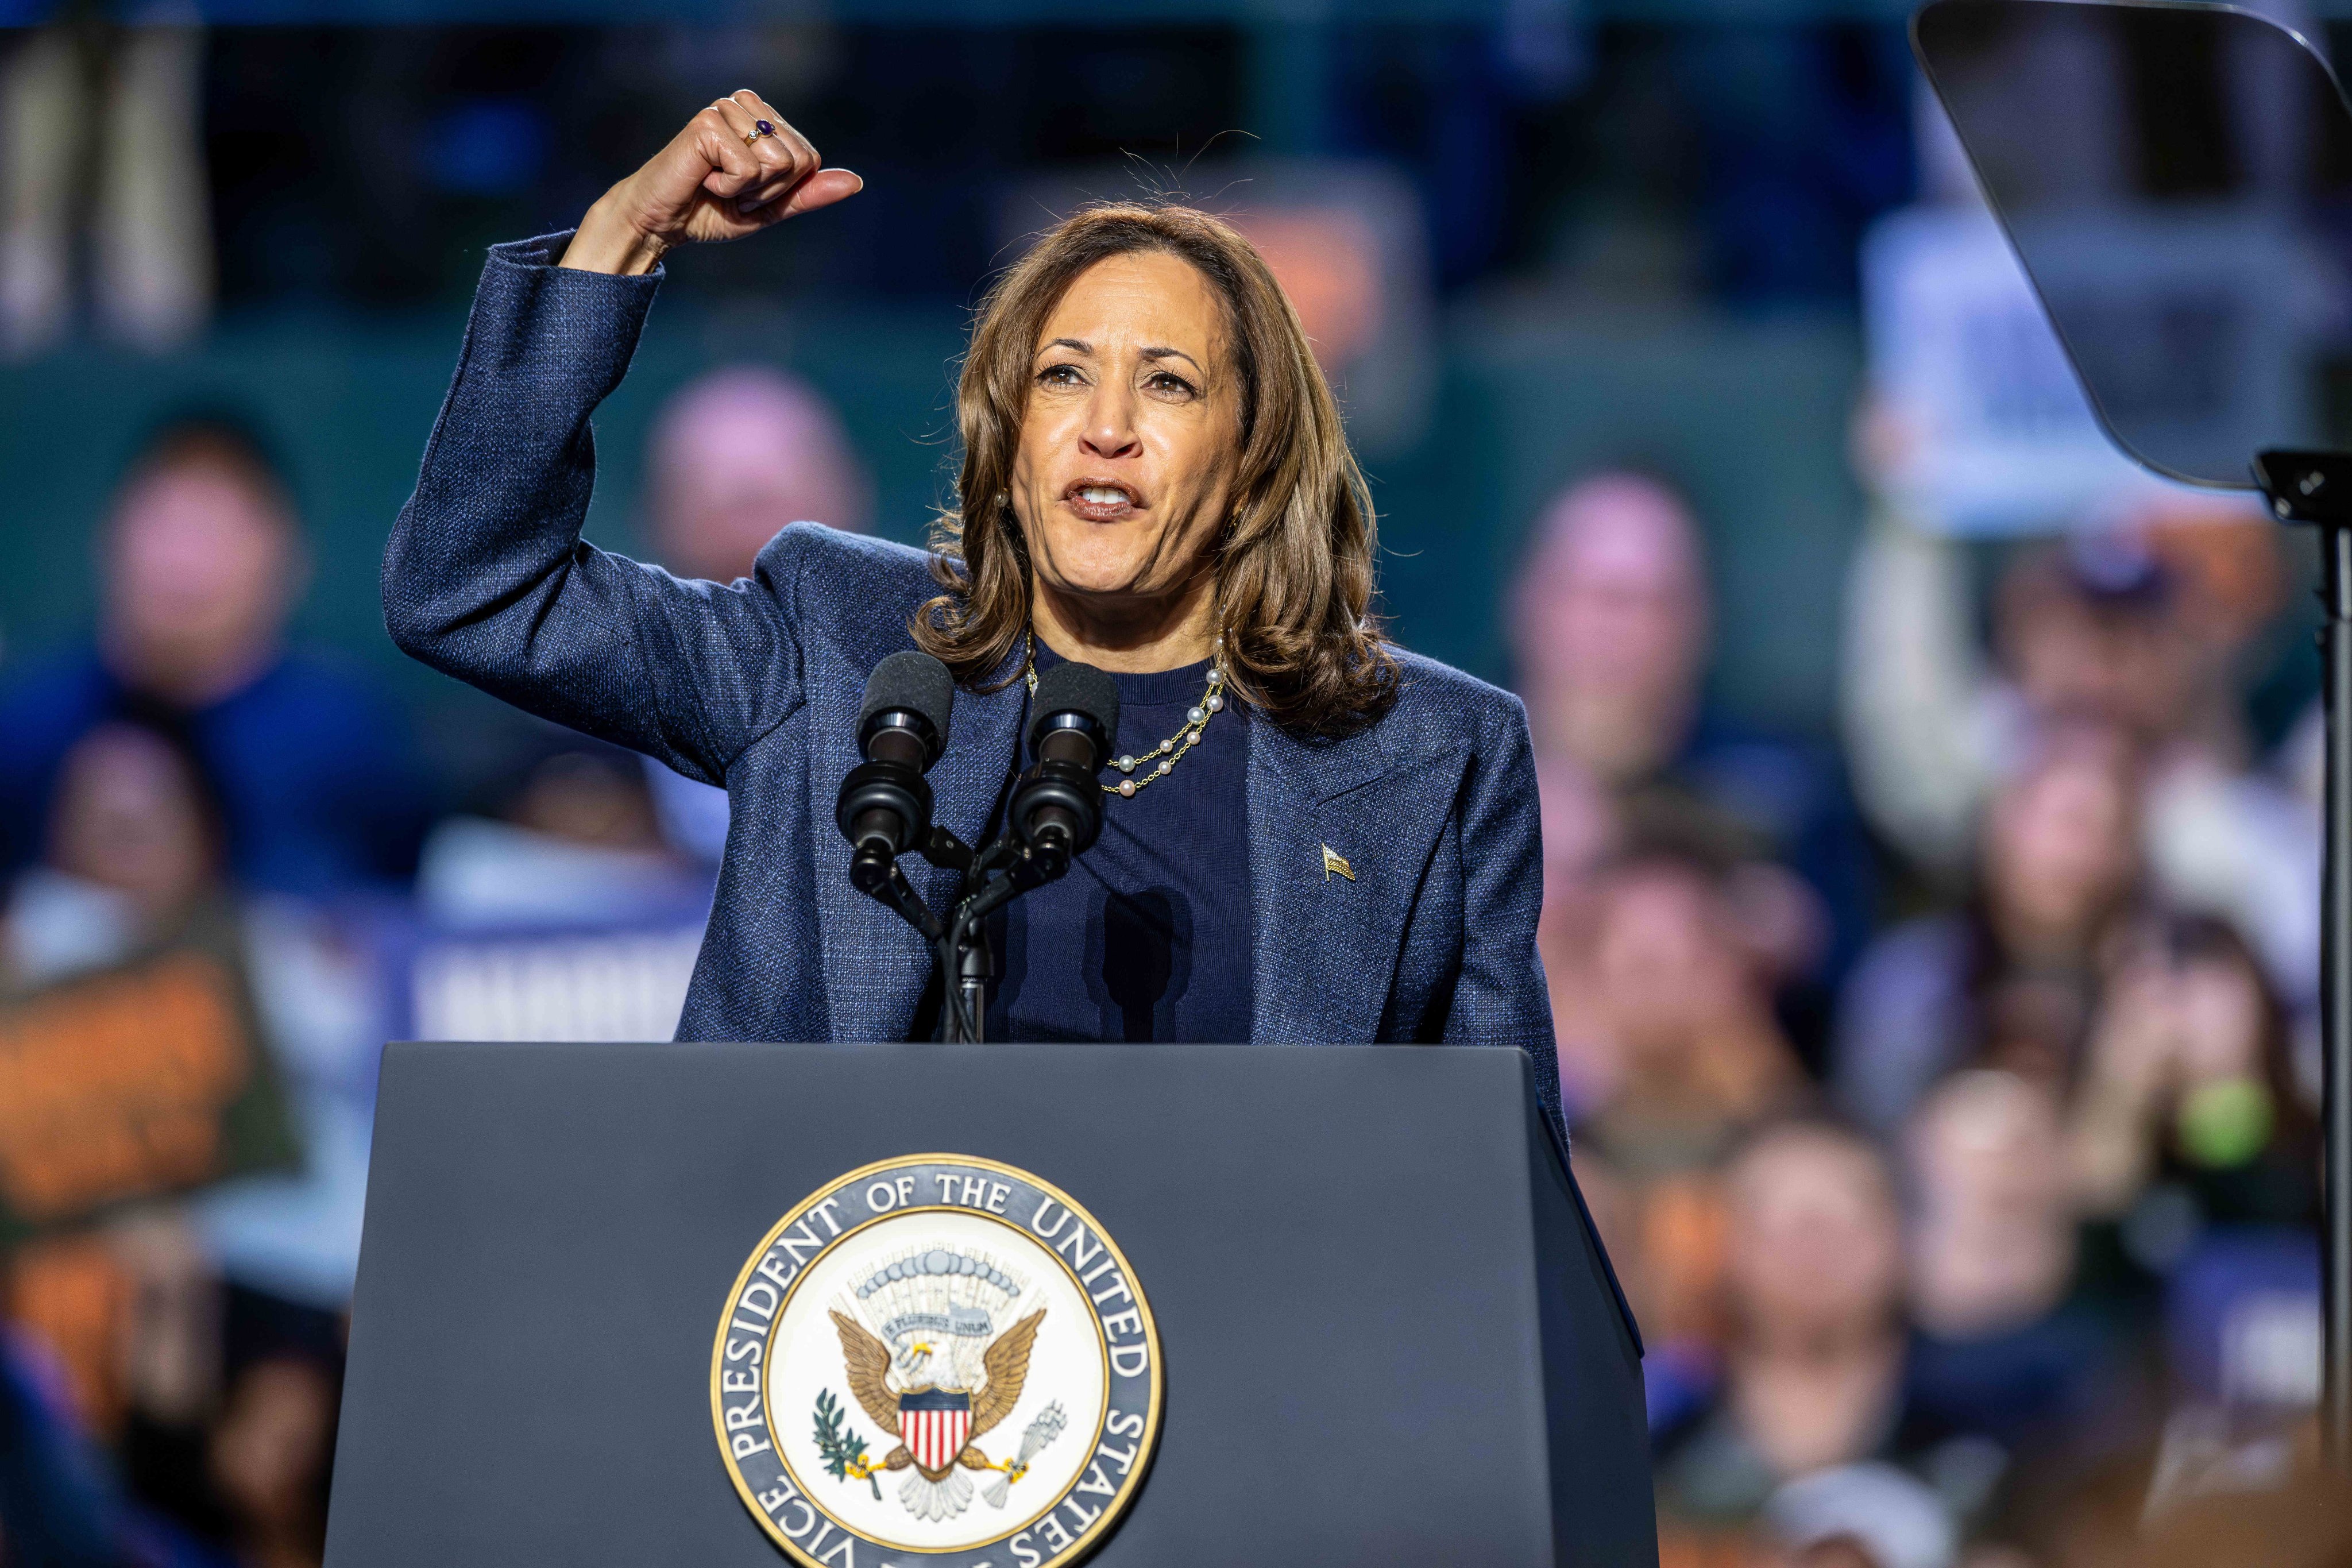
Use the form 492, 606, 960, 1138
640, 364, 872, 865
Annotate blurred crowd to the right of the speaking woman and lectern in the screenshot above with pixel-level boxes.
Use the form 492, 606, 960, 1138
1512, 456, 2338, 1568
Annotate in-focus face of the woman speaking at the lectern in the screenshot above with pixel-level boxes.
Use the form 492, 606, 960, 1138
1011, 252, 1242, 609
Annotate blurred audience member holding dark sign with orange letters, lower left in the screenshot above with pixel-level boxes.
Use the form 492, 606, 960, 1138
0, 712, 381, 1561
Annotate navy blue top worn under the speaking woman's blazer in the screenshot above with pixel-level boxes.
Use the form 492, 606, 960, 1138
988, 647, 1252, 1044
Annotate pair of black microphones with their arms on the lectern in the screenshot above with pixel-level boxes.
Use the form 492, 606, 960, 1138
833, 651, 1119, 1041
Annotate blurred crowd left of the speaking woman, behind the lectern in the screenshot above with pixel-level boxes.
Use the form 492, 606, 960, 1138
0, 364, 870, 1568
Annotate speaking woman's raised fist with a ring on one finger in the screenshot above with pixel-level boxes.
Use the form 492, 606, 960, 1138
562, 87, 866, 273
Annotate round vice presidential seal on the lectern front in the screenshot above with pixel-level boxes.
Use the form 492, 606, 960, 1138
710, 1154, 1162, 1568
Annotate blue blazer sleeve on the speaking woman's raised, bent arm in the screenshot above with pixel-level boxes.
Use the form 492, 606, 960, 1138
383, 235, 802, 783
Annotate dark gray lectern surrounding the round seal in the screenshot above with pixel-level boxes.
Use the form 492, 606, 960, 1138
327, 1044, 1658, 1568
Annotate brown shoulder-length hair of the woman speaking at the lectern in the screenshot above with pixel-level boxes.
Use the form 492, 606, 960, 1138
913, 202, 1397, 736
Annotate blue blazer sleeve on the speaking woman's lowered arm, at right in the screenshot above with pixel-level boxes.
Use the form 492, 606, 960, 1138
1444, 696, 1566, 1138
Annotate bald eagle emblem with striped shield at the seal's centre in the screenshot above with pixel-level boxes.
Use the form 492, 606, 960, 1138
816, 1246, 1065, 1521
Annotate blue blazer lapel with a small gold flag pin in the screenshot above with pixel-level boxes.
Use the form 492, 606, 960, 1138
1244, 708, 1465, 1046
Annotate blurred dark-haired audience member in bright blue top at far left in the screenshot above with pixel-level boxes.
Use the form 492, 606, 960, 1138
0, 421, 426, 898
